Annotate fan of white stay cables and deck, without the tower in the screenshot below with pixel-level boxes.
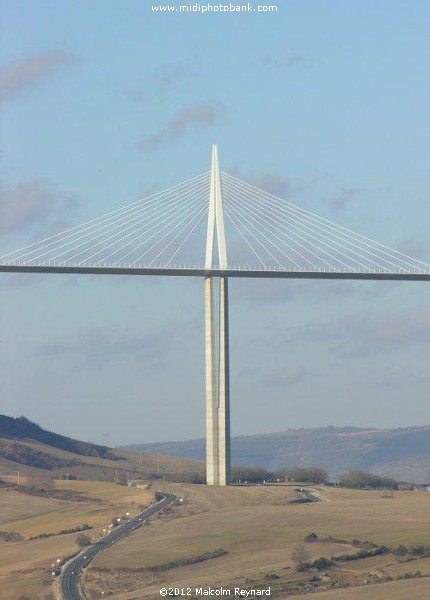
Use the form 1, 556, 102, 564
0, 155, 430, 279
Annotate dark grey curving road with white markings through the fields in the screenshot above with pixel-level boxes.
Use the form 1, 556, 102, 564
60, 492, 177, 600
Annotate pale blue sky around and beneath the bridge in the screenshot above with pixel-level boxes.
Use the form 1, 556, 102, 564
0, 0, 430, 445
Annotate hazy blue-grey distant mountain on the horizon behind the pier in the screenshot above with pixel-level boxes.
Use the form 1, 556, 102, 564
120, 426, 430, 482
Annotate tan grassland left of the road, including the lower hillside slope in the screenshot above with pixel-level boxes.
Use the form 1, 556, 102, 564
0, 428, 204, 600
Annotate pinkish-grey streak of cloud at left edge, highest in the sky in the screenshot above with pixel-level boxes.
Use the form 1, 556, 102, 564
0, 50, 76, 101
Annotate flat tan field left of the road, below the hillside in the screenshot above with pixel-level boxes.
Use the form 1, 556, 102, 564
0, 478, 153, 600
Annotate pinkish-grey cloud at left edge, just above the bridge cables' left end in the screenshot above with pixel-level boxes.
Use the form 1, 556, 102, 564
0, 180, 77, 235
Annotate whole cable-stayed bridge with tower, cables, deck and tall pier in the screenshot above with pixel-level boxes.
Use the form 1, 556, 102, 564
0, 146, 430, 485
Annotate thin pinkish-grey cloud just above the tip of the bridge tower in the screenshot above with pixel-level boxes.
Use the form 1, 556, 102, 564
139, 100, 226, 152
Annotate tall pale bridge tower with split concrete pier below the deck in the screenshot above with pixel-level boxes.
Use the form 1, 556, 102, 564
205, 145, 231, 485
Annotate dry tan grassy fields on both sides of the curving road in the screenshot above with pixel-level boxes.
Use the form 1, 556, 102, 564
0, 478, 430, 600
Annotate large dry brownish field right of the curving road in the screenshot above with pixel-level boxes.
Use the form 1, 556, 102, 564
85, 484, 430, 600
